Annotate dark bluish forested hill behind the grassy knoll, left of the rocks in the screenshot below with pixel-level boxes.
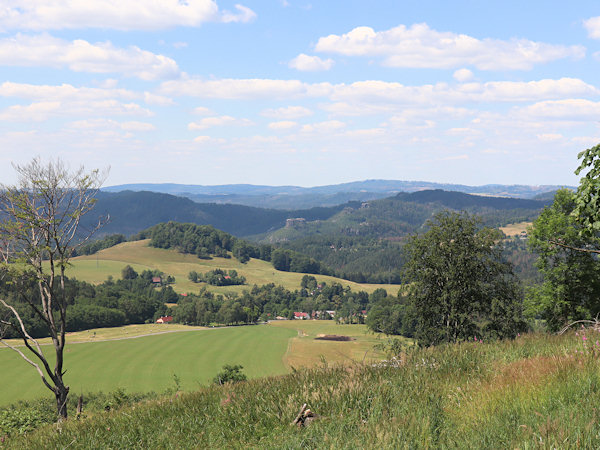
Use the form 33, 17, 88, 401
83, 191, 360, 236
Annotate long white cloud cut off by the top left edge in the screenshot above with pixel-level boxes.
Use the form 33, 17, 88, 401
0, 0, 256, 30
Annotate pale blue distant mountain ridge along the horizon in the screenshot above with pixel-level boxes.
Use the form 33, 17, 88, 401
103, 180, 574, 210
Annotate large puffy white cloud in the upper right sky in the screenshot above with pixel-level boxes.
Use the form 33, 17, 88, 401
315, 23, 585, 70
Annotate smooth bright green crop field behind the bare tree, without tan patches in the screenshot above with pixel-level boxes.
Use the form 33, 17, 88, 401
0, 325, 297, 405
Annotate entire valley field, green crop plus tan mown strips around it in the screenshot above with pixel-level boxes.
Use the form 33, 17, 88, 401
0, 320, 382, 406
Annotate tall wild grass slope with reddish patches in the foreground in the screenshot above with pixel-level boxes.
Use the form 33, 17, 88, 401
4, 334, 600, 448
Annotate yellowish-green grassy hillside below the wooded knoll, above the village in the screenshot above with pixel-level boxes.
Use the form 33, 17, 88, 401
68, 240, 399, 295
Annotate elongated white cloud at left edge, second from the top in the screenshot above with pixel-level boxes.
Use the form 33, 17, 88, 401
0, 34, 179, 80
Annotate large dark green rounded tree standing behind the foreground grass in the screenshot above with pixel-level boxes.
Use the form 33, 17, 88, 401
404, 212, 524, 346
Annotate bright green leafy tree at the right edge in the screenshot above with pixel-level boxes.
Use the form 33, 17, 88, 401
526, 189, 600, 331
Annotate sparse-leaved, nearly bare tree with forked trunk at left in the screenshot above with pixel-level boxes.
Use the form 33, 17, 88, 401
0, 158, 107, 420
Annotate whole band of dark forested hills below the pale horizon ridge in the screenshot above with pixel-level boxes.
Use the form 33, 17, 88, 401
84, 190, 544, 240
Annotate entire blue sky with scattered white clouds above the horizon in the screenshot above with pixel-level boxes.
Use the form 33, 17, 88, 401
0, 0, 600, 186
